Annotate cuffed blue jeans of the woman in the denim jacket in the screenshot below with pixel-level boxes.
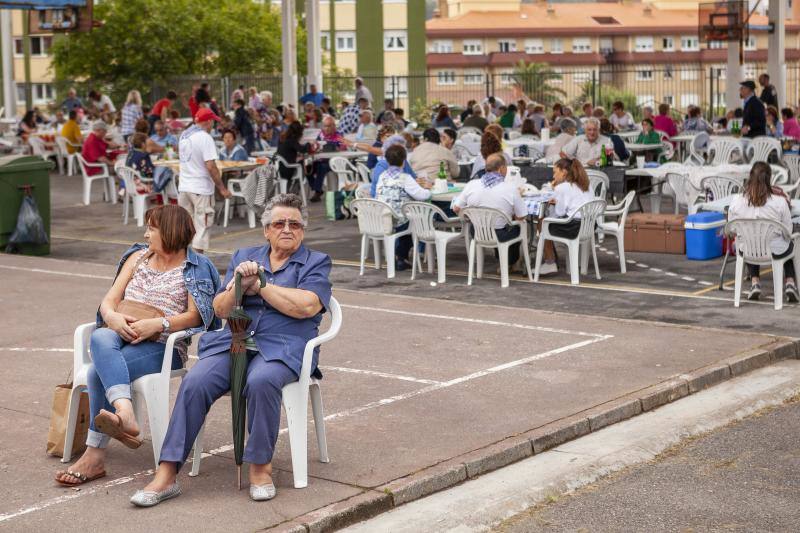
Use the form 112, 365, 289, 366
86, 328, 183, 448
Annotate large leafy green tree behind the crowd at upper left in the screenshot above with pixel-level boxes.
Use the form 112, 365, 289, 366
53, 0, 305, 100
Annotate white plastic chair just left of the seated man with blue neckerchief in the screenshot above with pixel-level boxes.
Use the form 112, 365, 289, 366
402, 202, 461, 283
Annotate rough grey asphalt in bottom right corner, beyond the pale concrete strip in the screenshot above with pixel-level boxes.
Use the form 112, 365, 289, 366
494, 398, 800, 533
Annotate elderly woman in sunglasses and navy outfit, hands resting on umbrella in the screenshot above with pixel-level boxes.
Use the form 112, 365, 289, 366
131, 194, 331, 507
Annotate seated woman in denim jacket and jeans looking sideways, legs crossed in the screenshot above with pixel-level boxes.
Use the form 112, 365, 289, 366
55, 205, 220, 486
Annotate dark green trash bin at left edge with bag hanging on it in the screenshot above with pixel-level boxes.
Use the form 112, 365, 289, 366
0, 155, 55, 255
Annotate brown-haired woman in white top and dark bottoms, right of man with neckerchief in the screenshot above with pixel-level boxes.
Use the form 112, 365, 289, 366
539, 159, 594, 274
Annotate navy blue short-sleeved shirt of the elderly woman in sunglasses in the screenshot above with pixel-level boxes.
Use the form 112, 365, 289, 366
198, 244, 332, 376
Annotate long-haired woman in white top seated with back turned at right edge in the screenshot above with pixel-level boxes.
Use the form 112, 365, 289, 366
728, 161, 800, 302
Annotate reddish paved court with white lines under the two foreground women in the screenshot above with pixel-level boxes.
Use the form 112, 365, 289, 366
0, 256, 797, 531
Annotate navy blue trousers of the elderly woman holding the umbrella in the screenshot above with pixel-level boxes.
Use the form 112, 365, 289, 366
159, 352, 297, 469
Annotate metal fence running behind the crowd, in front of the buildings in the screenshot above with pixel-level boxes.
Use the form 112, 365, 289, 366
40, 63, 800, 122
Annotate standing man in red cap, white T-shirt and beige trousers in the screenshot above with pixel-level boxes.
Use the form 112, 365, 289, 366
178, 107, 231, 253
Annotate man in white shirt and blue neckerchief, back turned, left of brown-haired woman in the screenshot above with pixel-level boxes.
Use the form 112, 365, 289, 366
453, 153, 528, 270
